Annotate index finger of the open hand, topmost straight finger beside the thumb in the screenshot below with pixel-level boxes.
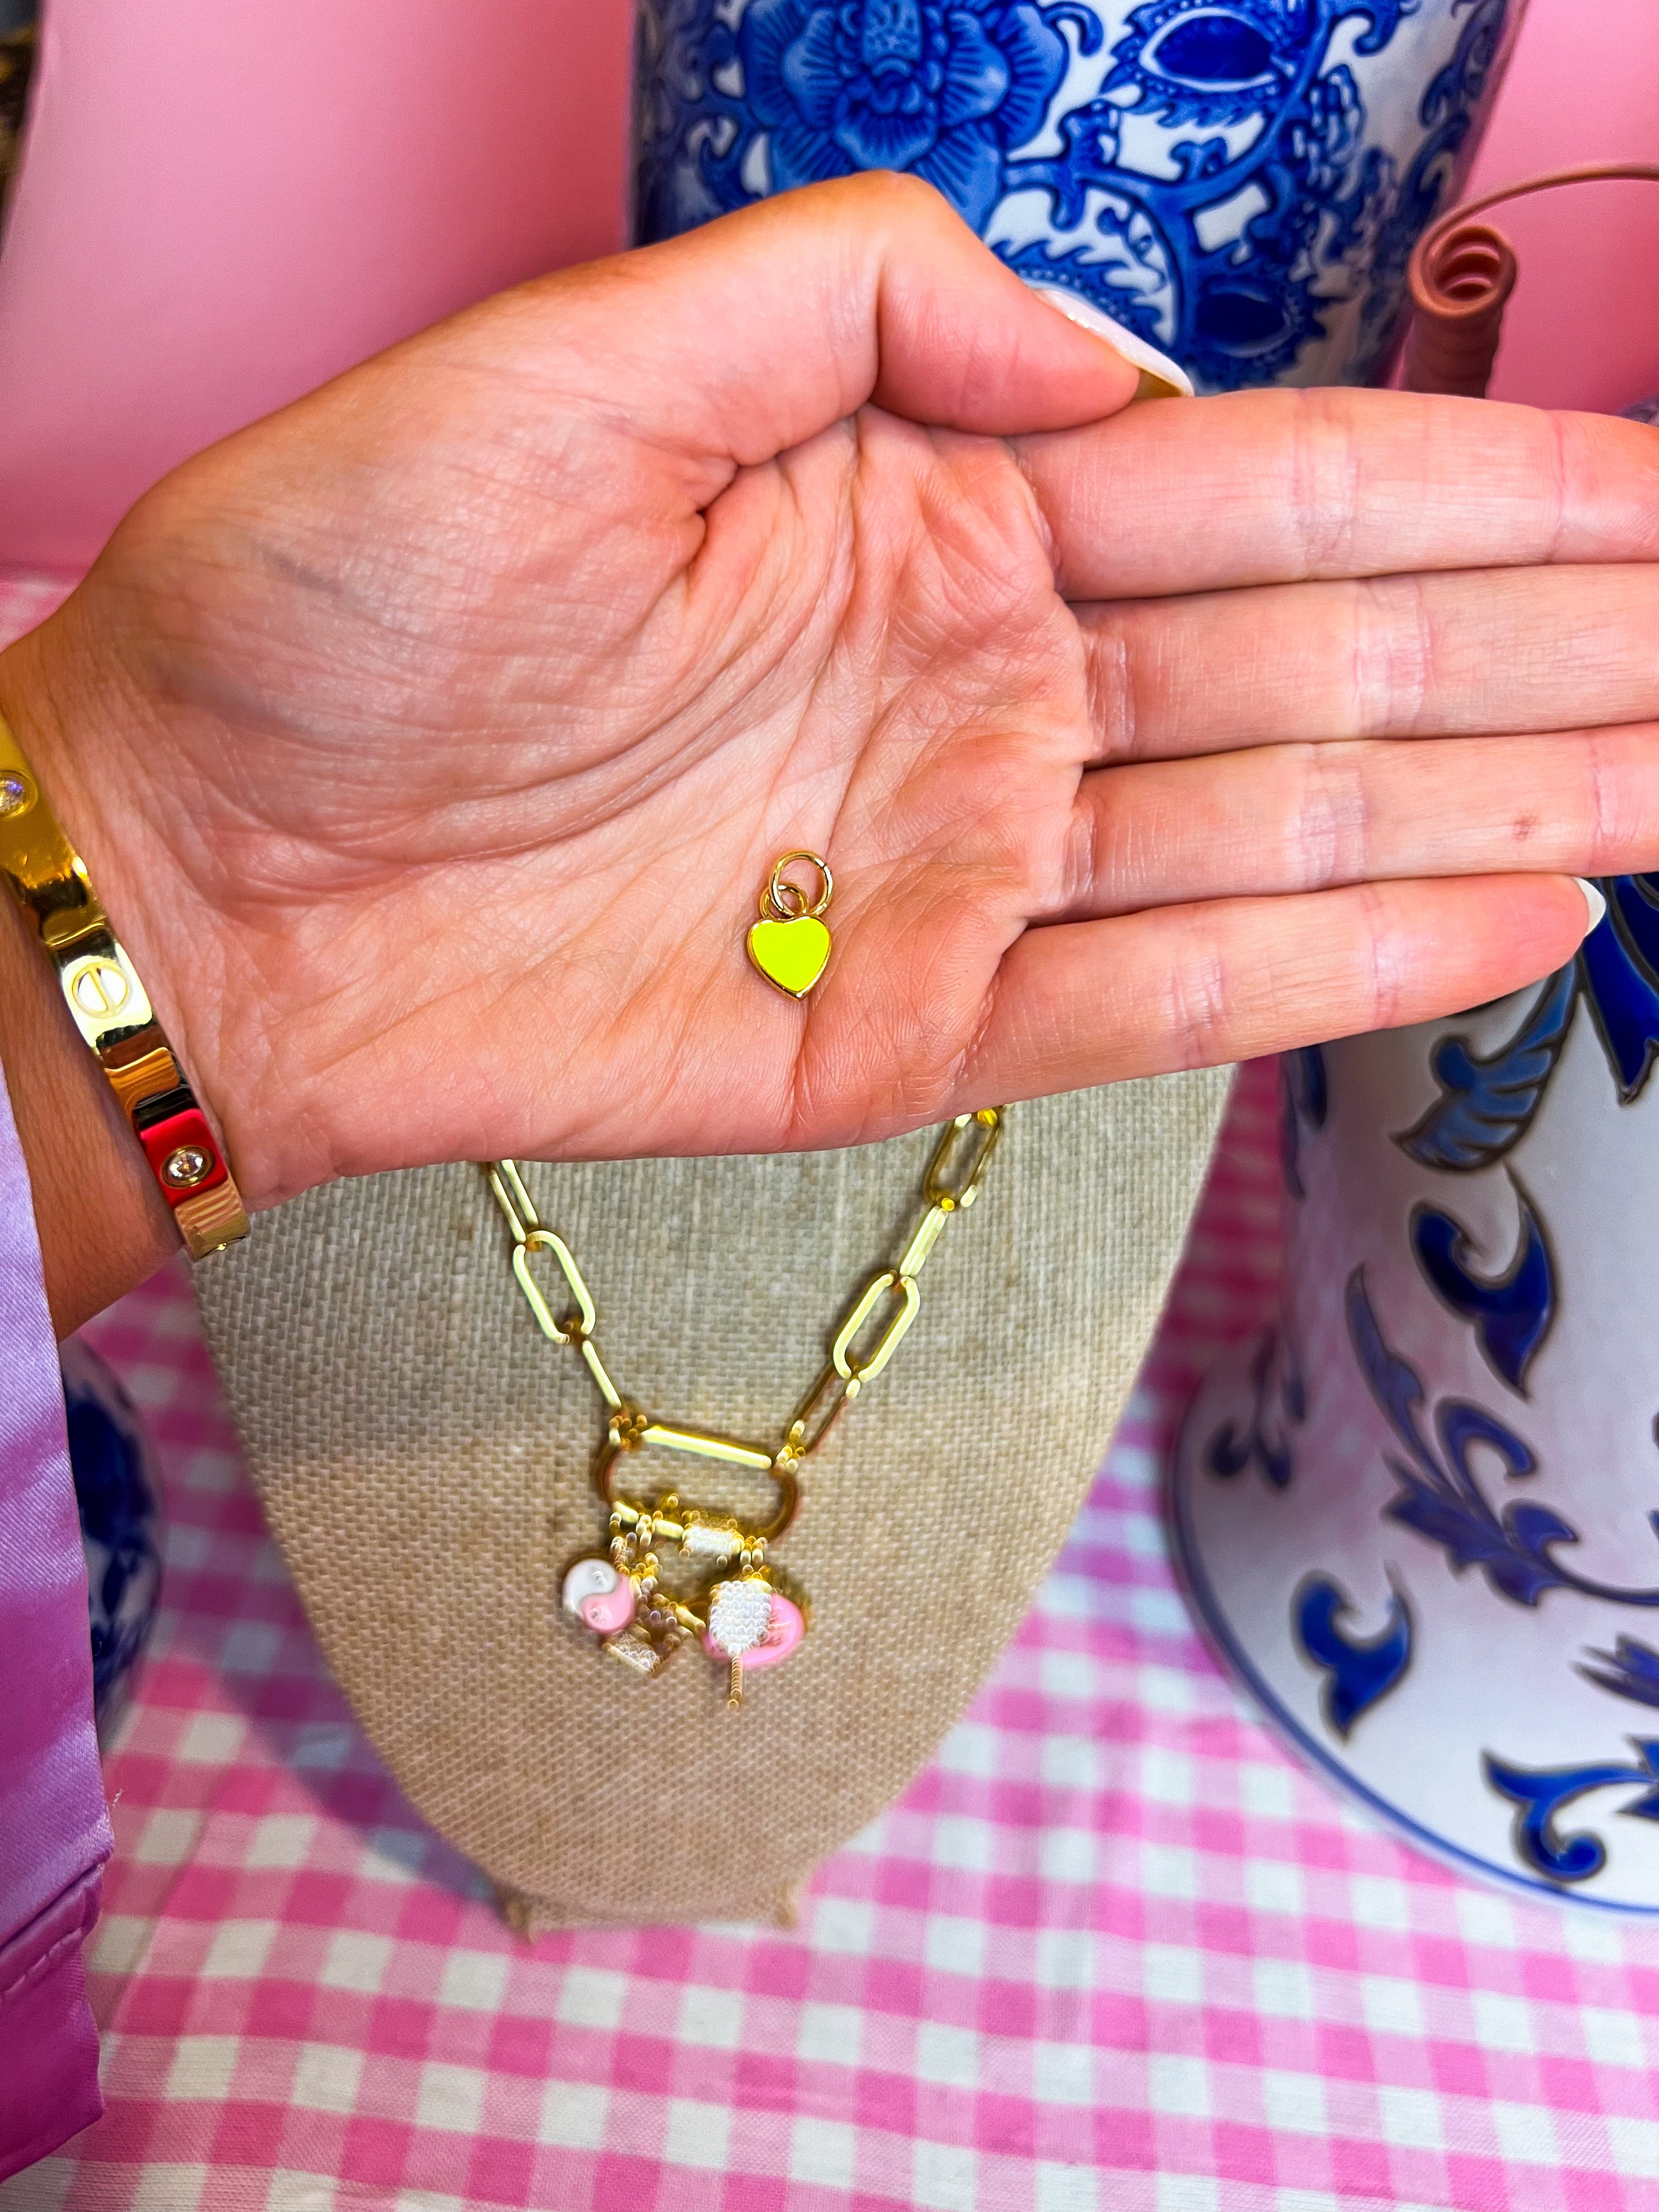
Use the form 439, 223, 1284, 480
1015, 390, 1659, 600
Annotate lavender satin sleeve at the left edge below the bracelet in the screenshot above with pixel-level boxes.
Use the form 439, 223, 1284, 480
0, 1053, 111, 2181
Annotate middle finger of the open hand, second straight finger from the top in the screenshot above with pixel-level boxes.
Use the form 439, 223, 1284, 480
1075, 566, 1659, 761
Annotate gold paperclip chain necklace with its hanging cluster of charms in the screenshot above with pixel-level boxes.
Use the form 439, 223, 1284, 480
484, 1106, 1007, 1706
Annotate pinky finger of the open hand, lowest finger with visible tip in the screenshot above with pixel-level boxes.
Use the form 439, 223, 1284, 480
962, 876, 1590, 1106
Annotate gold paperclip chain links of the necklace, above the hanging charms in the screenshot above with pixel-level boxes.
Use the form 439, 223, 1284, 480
482, 1106, 1009, 1486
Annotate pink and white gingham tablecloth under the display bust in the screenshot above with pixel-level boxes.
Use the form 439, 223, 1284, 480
0, 593, 1659, 2212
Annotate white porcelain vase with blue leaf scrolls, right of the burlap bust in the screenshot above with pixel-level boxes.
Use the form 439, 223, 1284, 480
1170, 876, 1659, 1911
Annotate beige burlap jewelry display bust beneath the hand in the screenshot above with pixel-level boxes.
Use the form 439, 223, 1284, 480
197, 1070, 1226, 1929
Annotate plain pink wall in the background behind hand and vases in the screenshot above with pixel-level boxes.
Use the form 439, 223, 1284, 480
0, 0, 1659, 571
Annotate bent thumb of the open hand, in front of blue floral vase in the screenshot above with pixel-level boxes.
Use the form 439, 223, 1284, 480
533, 172, 1142, 465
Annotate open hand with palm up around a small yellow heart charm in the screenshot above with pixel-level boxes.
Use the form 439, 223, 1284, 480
0, 177, 1659, 1309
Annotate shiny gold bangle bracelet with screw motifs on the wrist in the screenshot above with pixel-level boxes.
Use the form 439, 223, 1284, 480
0, 716, 248, 1259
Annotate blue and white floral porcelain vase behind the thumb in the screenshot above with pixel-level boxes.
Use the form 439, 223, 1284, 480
635, 0, 1524, 392
